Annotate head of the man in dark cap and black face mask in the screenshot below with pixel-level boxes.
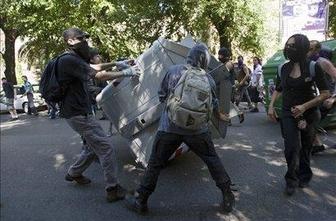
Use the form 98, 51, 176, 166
63, 28, 90, 61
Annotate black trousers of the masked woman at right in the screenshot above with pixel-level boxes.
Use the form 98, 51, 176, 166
281, 112, 319, 186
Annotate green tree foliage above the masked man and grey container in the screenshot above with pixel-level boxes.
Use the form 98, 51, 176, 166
1, 0, 264, 67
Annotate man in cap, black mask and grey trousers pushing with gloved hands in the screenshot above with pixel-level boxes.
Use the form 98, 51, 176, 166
57, 28, 140, 202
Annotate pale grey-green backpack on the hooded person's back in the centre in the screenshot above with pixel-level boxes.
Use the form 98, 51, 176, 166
167, 65, 212, 130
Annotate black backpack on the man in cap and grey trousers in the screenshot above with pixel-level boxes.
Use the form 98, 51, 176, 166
39, 53, 71, 102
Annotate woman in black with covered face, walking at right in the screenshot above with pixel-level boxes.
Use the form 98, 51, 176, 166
268, 34, 330, 196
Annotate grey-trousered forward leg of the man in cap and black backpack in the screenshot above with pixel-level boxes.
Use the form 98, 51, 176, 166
67, 116, 118, 188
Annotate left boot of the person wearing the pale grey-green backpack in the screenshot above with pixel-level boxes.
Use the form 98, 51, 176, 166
126, 192, 148, 215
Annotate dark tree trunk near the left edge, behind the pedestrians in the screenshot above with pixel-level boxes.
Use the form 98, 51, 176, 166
3, 30, 17, 84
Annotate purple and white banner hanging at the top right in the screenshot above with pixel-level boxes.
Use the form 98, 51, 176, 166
282, 0, 328, 43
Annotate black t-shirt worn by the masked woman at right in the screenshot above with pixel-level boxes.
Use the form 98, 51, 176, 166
276, 62, 328, 111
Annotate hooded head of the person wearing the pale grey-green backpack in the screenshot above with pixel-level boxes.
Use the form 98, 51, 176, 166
187, 44, 210, 70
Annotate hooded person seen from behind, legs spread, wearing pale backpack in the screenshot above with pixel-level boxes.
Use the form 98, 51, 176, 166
126, 44, 235, 214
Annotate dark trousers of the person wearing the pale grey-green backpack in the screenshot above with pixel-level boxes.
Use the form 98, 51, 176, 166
137, 131, 231, 196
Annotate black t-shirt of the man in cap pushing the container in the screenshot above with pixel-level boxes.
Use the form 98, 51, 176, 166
57, 53, 95, 118
